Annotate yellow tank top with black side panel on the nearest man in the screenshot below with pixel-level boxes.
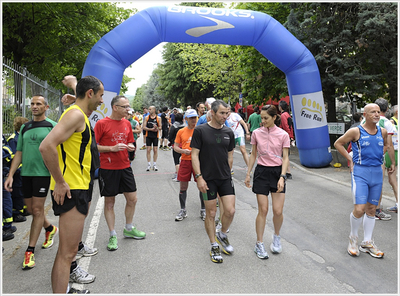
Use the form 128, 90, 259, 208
50, 105, 92, 190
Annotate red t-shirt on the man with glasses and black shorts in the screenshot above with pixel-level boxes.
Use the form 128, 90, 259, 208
94, 117, 135, 170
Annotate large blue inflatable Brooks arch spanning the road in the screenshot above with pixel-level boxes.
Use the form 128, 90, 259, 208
82, 6, 332, 167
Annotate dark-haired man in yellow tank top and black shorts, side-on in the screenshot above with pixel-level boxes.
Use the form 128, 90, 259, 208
39, 76, 104, 293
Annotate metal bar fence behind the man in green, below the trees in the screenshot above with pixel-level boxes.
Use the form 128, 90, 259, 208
1, 57, 63, 136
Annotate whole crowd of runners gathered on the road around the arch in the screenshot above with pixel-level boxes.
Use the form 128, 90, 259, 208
3, 76, 398, 293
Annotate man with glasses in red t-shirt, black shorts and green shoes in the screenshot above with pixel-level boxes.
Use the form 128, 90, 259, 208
94, 96, 146, 251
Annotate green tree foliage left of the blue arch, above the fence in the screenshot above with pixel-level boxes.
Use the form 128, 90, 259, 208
2, 2, 134, 89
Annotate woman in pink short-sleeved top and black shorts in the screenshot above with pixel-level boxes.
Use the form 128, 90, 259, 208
244, 105, 290, 259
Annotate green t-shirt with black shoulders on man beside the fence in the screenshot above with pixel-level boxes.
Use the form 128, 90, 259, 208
17, 118, 56, 177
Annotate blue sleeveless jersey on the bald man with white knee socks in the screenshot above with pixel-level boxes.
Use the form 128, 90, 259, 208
351, 125, 384, 166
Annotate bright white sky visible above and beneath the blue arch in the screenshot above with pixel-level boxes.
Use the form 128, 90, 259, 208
117, 1, 182, 96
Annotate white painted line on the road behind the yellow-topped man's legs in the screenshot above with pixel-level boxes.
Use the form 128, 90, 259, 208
72, 196, 104, 290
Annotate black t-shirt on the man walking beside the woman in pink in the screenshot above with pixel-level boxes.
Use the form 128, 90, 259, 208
190, 124, 235, 180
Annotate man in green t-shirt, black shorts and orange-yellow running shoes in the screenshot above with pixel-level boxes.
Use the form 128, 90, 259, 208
4, 95, 58, 269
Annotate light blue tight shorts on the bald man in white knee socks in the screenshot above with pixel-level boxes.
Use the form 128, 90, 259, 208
351, 164, 383, 205
